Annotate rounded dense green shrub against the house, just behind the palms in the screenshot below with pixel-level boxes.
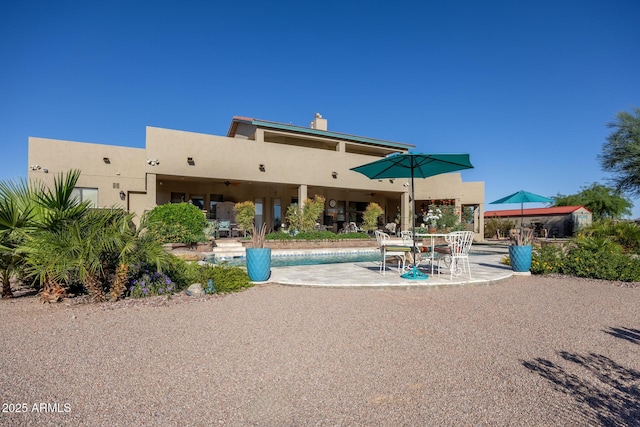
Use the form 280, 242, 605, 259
144, 203, 207, 243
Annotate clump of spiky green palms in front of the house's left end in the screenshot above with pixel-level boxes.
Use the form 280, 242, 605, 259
7, 170, 176, 301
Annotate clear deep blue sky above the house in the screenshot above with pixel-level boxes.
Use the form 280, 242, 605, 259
0, 0, 640, 218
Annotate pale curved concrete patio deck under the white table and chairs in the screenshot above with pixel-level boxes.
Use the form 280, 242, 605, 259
260, 246, 513, 288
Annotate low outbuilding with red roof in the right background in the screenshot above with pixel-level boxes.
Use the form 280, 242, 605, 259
484, 206, 593, 237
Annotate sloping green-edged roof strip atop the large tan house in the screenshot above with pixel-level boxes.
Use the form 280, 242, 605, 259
227, 116, 415, 151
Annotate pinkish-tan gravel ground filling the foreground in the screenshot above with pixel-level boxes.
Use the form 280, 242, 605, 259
0, 276, 640, 426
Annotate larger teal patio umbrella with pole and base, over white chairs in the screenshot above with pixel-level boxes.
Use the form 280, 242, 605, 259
351, 153, 473, 280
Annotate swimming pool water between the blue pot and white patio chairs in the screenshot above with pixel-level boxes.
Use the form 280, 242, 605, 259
205, 249, 495, 267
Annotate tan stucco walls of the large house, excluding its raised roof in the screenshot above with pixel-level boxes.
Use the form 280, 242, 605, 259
28, 127, 484, 235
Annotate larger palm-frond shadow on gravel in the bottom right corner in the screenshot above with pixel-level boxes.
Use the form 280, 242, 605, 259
522, 351, 640, 426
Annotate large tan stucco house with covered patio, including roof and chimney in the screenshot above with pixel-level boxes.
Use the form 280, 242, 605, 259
28, 114, 484, 239
